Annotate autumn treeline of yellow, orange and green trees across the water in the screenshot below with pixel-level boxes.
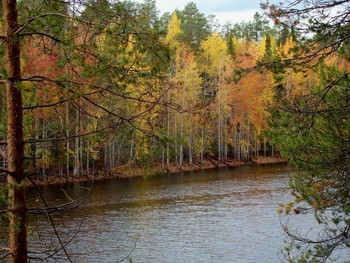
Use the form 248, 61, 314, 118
0, 0, 342, 179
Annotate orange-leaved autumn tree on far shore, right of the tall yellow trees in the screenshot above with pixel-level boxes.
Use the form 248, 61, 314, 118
225, 37, 273, 160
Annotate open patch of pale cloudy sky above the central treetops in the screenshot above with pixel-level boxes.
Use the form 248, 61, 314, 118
154, 0, 261, 25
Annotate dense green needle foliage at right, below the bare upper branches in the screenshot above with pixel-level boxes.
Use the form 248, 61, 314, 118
270, 60, 350, 262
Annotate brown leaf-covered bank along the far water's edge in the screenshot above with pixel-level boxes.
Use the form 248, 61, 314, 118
23, 157, 287, 188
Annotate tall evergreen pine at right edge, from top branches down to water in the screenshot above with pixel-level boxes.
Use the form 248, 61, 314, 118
268, 0, 350, 262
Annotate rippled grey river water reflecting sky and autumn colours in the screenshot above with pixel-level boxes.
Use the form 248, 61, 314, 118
24, 165, 300, 263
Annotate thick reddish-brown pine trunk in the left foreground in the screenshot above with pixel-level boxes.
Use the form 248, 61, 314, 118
2, 0, 28, 262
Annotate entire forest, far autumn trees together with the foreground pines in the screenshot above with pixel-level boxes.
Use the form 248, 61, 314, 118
0, 0, 350, 262
